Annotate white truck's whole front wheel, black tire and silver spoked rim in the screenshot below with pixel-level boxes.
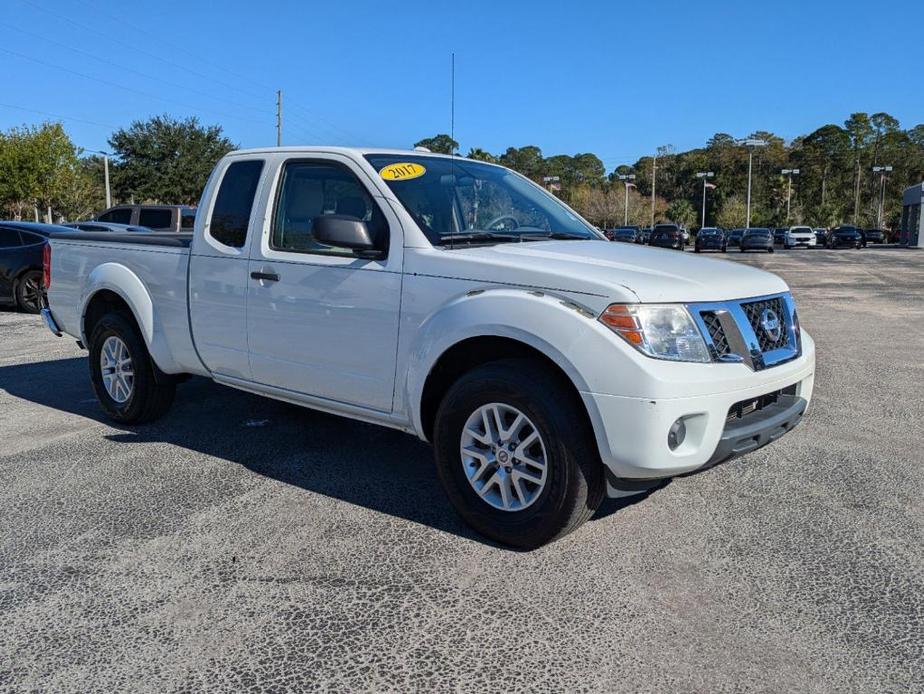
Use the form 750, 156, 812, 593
433, 359, 605, 549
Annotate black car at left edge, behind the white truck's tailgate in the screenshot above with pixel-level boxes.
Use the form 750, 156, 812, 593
0, 222, 64, 313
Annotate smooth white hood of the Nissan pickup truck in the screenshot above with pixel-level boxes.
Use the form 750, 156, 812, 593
406, 241, 788, 303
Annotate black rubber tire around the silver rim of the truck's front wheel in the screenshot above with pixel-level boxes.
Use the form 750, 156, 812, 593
433, 359, 606, 549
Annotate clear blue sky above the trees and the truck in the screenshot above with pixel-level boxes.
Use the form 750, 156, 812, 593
0, 0, 924, 169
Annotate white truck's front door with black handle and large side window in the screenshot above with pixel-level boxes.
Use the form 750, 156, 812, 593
247, 155, 403, 412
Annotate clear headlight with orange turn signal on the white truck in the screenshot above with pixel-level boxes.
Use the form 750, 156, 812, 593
599, 304, 712, 362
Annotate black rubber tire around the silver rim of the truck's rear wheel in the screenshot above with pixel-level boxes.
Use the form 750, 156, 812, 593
89, 313, 176, 424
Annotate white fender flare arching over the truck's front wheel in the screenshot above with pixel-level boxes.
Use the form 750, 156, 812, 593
403, 288, 597, 439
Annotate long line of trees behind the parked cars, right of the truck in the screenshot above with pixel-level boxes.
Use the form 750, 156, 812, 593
415, 113, 924, 229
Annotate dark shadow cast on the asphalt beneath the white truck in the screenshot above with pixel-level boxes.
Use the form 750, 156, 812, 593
0, 358, 647, 546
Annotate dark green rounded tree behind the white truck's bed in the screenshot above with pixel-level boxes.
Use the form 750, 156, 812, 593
109, 115, 235, 204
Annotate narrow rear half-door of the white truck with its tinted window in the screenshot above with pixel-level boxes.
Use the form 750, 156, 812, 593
189, 158, 263, 380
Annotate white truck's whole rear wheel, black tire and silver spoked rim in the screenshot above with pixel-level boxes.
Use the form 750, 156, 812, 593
89, 313, 176, 424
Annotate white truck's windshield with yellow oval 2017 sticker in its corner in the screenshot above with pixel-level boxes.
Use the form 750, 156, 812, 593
366, 154, 601, 246
